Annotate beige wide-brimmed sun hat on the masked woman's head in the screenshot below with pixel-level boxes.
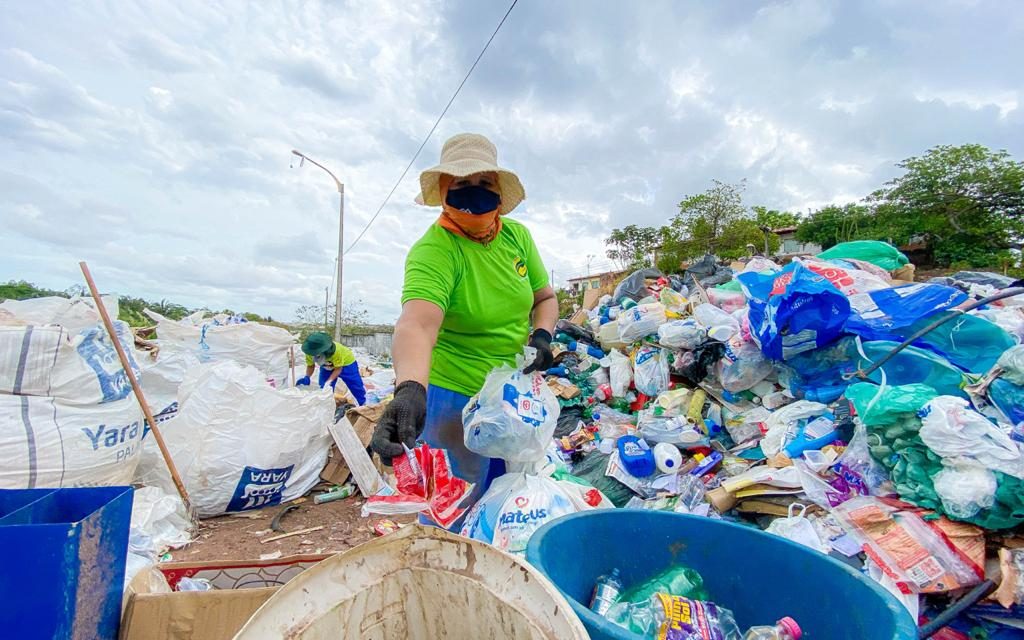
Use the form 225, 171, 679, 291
416, 133, 526, 215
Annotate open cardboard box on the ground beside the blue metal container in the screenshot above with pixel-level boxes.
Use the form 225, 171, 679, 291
119, 554, 330, 640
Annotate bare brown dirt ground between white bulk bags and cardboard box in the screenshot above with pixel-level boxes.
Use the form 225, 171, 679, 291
178, 492, 415, 561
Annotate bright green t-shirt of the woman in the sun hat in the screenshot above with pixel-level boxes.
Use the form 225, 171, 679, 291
401, 218, 548, 395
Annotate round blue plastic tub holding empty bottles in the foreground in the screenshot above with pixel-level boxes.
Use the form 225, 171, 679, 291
526, 509, 918, 640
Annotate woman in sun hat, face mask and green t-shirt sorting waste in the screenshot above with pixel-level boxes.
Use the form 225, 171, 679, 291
372, 133, 558, 530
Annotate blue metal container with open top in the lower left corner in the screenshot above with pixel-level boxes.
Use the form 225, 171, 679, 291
0, 486, 132, 640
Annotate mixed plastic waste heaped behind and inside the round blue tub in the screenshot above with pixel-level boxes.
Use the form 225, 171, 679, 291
528, 241, 1024, 638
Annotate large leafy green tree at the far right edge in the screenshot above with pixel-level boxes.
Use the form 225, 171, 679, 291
868, 144, 1024, 266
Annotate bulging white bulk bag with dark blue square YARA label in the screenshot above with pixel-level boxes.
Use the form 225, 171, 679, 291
140, 360, 335, 517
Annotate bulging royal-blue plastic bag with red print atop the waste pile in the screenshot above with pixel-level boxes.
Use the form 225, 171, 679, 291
738, 262, 850, 360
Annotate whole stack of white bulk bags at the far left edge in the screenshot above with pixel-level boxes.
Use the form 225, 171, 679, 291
0, 298, 144, 488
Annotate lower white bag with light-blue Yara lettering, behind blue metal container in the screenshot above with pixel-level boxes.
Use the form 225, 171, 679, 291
0, 394, 145, 488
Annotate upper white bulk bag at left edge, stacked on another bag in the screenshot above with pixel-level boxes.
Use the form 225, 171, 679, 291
0, 321, 139, 404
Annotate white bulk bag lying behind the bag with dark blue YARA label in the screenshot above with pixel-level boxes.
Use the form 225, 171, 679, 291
145, 309, 301, 387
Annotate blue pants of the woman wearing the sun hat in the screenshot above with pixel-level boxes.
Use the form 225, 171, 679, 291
420, 385, 505, 532
